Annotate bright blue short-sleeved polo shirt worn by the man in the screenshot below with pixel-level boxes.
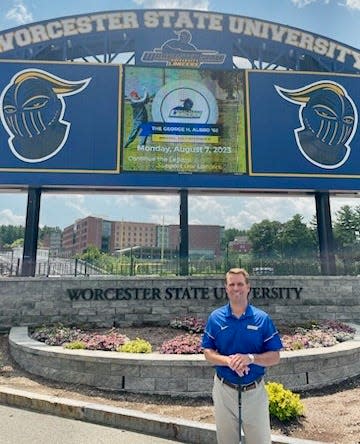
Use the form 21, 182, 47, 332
202, 304, 283, 384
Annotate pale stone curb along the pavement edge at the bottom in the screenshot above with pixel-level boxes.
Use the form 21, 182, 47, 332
0, 387, 326, 444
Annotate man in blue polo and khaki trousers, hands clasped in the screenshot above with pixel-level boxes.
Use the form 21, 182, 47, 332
202, 268, 282, 444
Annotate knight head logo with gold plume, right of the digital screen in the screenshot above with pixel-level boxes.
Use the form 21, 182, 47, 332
275, 81, 358, 169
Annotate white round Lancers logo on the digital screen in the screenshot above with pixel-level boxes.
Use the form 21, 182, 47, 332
152, 80, 218, 124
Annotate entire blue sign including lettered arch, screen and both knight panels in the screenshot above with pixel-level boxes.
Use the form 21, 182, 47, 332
0, 10, 360, 192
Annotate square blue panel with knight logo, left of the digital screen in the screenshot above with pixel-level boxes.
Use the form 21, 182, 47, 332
0, 62, 120, 173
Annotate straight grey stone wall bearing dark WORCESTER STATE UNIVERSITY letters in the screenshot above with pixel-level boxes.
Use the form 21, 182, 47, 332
0, 276, 360, 331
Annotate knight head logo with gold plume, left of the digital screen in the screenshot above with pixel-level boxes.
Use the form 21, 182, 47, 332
0, 69, 91, 163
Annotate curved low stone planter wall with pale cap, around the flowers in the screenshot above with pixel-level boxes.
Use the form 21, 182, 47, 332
10, 327, 360, 397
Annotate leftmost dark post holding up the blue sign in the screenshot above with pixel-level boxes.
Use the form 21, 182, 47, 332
21, 188, 41, 276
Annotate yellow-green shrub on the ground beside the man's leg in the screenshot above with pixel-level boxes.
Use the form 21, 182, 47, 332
265, 382, 305, 421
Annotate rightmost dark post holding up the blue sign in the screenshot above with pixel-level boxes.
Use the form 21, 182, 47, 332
315, 192, 336, 276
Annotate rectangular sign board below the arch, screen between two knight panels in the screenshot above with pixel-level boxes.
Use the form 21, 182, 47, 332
0, 62, 360, 191
